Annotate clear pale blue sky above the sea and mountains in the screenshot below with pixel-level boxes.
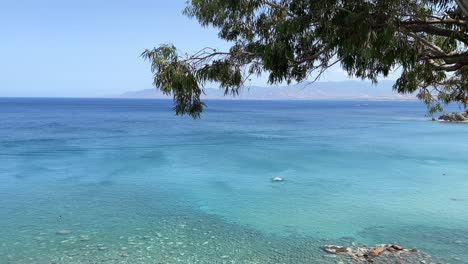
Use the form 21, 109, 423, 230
0, 0, 400, 97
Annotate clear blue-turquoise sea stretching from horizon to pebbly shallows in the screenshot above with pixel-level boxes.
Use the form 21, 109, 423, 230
0, 99, 468, 263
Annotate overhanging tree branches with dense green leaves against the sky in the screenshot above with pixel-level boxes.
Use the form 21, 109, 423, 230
142, 0, 468, 117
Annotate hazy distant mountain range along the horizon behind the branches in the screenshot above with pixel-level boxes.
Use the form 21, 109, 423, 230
118, 81, 415, 100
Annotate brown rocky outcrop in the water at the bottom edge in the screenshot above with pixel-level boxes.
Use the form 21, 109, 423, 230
322, 244, 434, 264
